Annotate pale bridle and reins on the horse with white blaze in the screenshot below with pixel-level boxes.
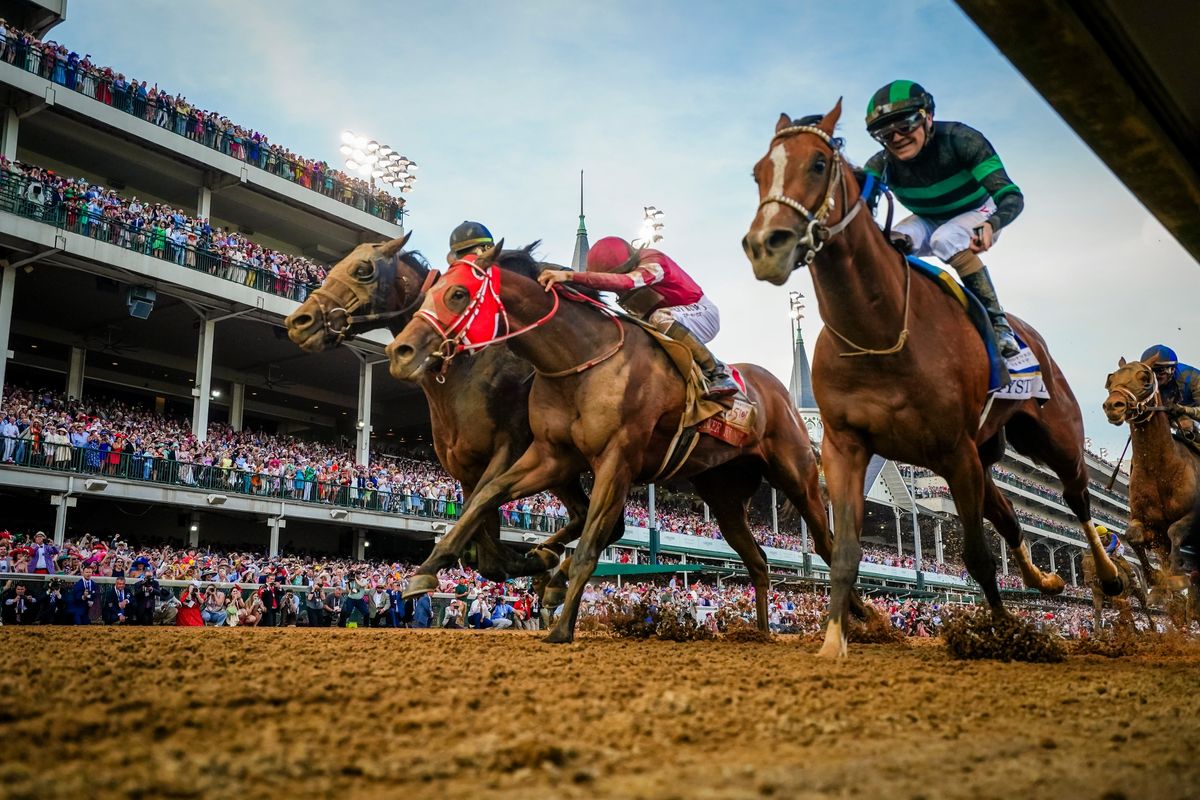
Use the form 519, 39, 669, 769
758, 125, 912, 359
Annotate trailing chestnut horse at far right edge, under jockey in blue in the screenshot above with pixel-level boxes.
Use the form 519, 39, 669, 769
1104, 359, 1200, 606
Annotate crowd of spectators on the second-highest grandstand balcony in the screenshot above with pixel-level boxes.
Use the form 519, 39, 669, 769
0, 156, 328, 301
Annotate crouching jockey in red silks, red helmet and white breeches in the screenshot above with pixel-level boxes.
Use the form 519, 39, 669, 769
538, 236, 738, 398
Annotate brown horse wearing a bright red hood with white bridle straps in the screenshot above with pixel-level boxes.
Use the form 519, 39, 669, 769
388, 246, 832, 642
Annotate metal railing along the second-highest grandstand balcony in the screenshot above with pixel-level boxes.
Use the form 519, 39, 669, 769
0, 173, 319, 302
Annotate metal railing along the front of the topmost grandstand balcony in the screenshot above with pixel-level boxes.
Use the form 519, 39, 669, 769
5, 44, 404, 224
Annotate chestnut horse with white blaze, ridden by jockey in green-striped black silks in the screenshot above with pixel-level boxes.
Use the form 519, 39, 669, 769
742, 101, 1122, 656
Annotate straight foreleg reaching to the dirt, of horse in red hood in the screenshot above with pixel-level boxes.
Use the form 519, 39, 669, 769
546, 452, 630, 644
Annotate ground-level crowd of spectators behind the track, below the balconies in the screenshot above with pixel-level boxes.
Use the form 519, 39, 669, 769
0, 531, 1128, 637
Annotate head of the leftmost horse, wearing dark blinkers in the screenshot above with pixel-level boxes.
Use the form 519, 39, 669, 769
284, 233, 427, 353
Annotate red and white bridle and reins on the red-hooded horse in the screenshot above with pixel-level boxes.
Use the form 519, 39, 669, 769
413, 259, 625, 383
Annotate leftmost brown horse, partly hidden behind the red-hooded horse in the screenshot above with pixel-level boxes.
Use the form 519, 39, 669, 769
286, 234, 588, 581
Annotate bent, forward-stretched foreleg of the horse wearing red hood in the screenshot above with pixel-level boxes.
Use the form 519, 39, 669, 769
404, 444, 564, 597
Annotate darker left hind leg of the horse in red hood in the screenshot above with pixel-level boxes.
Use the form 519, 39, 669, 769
691, 464, 770, 633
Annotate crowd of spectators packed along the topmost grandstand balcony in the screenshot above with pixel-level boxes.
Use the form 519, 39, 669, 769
0, 19, 404, 224
